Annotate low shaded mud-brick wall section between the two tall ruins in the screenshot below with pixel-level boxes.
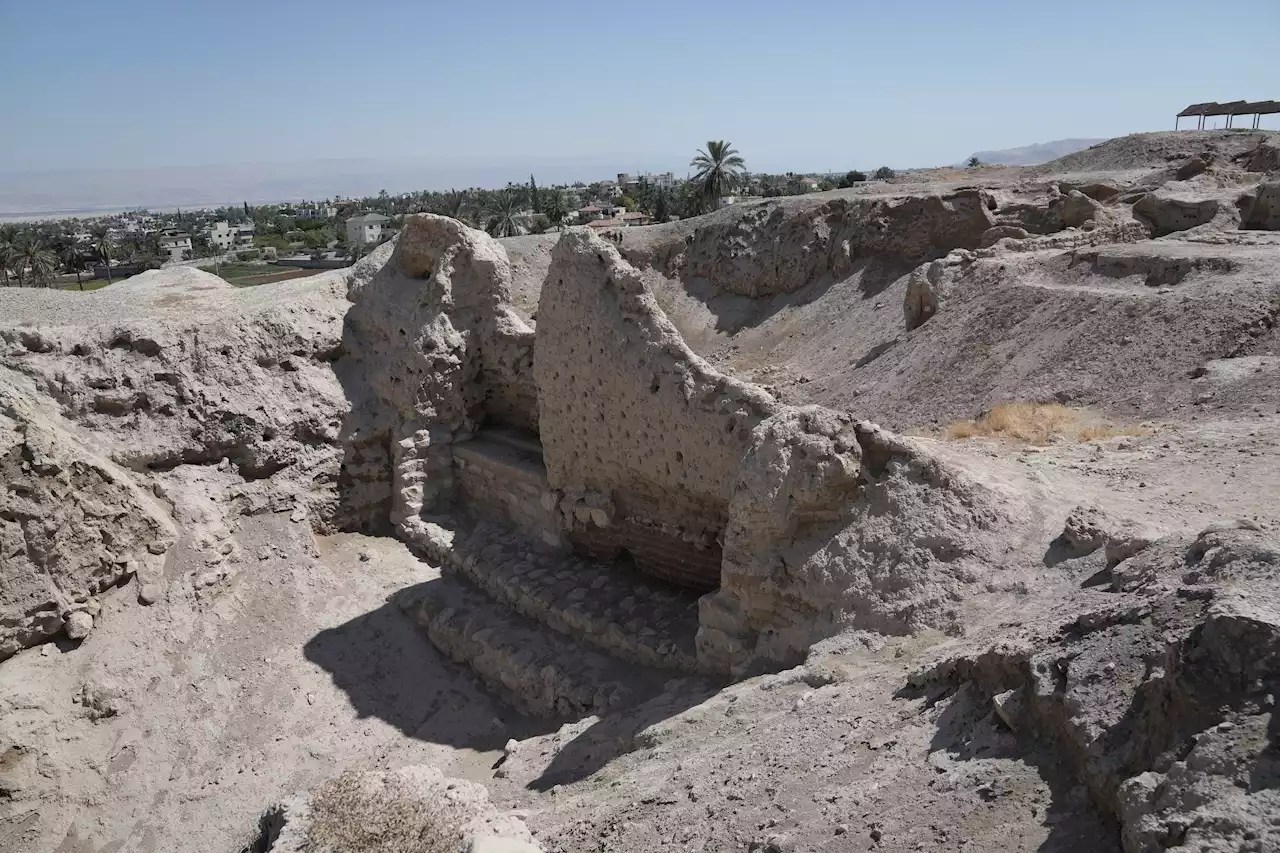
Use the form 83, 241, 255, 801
453, 438, 563, 547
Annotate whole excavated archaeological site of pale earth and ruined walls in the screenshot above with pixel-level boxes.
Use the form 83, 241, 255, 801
0, 131, 1280, 853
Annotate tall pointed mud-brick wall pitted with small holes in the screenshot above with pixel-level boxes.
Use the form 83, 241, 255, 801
534, 232, 778, 588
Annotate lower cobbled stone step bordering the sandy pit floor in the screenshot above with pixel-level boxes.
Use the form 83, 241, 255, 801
397, 575, 671, 720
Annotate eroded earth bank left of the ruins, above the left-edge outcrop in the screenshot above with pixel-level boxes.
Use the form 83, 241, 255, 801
0, 268, 347, 517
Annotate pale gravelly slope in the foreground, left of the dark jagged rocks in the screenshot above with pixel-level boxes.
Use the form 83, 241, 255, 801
493, 638, 1119, 853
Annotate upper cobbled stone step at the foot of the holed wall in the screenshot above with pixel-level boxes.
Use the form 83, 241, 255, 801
401, 521, 698, 672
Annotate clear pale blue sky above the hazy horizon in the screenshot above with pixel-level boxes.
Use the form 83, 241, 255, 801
0, 0, 1280, 177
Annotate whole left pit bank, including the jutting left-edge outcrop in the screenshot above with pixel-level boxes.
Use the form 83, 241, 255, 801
0, 268, 346, 657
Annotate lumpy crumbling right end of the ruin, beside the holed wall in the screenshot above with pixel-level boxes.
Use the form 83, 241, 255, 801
698, 407, 1009, 675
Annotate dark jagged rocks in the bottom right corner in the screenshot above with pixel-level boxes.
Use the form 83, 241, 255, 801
916, 525, 1280, 853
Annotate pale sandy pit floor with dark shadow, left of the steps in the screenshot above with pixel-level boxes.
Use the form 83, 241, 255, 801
0, 512, 521, 853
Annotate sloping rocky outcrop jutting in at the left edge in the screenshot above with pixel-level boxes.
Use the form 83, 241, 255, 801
0, 373, 175, 661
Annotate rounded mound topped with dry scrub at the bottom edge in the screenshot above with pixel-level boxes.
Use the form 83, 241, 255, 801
259, 766, 541, 853
